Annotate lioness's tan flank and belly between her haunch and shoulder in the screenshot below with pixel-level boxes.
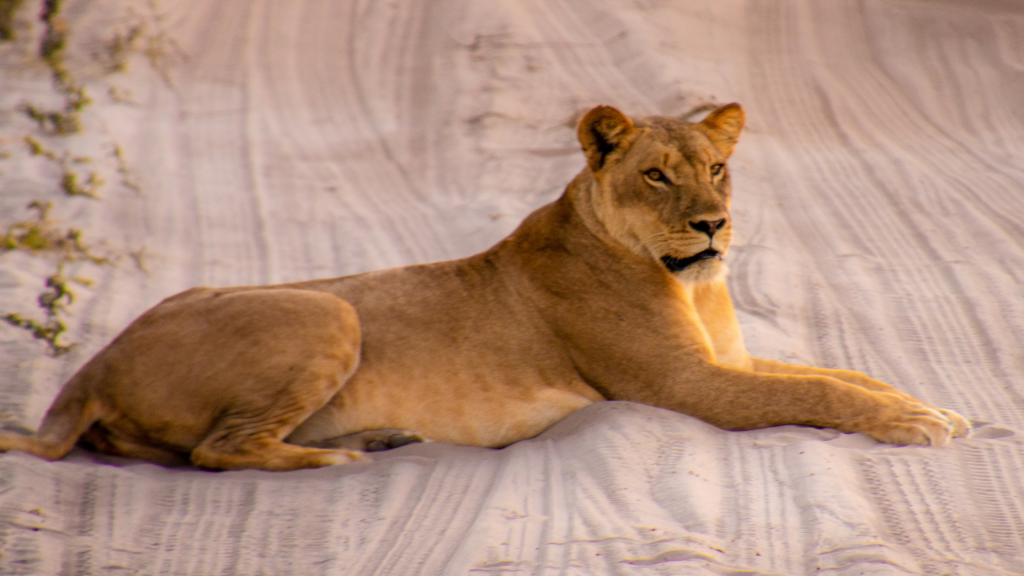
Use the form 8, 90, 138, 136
289, 258, 603, 447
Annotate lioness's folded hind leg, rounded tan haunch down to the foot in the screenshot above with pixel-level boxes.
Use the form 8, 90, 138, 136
102, 289, 362, 470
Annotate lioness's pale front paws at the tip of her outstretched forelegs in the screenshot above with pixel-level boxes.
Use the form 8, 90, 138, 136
861, 393, 971, 446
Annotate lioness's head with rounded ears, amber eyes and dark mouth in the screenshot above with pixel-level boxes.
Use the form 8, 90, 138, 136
578, 104, 745, 283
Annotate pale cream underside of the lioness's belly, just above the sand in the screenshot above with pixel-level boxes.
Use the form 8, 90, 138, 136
289, 364, 603, 447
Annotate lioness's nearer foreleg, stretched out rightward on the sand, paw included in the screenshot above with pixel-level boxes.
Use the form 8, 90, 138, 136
643, 363, 955, 446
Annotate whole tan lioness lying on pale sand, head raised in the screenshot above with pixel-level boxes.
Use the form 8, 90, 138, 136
0, 104, 970, 470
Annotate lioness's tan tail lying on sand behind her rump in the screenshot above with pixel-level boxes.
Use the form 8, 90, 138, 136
0, 372, 101, 460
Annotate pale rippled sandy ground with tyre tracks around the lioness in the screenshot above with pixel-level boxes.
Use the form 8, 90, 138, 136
0, 0, 1024, 575
